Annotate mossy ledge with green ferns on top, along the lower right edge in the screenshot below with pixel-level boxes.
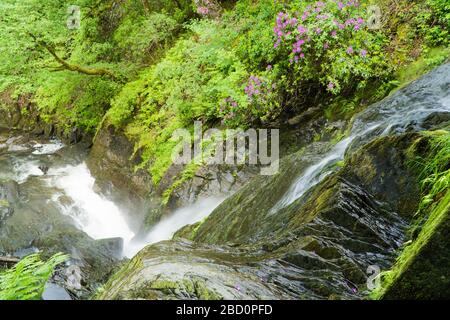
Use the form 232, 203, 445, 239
370, 129, 450, 300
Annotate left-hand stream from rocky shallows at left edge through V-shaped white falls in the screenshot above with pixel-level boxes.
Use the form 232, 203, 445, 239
0, 136, 223, 257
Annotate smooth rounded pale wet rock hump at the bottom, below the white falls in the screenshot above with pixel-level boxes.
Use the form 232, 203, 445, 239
97, 241, 289, 300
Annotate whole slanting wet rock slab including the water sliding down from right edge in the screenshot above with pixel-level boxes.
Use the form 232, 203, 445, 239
97, 64, 450, 299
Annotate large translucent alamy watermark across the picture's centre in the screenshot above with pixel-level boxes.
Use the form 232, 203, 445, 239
172, 121, 280, 175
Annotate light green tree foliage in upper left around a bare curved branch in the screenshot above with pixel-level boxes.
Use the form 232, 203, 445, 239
0, 0, 192, 132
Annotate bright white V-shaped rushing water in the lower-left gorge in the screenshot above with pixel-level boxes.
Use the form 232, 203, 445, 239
44, 163, 223, 258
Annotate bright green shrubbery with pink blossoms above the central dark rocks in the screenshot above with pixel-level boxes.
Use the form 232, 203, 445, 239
106, 0, 450, 192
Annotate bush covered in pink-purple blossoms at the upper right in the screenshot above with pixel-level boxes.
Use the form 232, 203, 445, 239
273, 0, 386, 94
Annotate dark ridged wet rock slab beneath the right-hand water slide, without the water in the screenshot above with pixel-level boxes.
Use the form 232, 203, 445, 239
99, 134, 417, 299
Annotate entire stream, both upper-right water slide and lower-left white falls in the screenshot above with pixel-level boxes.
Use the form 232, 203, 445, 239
0, 64, 450, 300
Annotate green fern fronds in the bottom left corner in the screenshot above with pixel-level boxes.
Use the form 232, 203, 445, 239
0, 253, 69, 300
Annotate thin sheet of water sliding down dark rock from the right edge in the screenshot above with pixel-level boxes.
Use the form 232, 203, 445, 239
269, 64, 450, 215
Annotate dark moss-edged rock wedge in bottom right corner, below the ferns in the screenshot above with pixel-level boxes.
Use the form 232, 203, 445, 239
371, 190, 450, 300
